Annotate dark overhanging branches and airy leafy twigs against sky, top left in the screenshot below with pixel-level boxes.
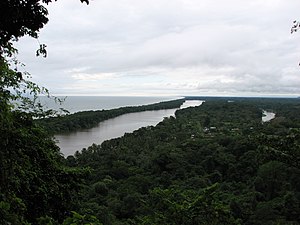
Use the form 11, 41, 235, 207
0, 0, 89, 116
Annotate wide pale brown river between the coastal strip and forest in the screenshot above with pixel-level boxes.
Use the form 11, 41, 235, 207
55, 100, 203, 156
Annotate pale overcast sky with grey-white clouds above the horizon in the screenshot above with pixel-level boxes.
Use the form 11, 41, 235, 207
16, 0, 300, 97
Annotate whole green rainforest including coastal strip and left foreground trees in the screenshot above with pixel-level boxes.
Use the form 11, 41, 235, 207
0, 0, 300, 225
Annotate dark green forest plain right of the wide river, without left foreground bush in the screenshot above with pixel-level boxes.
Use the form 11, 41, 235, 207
62, 99, 300, 224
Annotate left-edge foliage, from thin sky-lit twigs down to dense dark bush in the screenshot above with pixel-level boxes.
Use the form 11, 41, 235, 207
0, 51, 96, 225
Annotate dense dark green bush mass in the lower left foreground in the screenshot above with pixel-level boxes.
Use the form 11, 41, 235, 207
0, 103, 89, 224
